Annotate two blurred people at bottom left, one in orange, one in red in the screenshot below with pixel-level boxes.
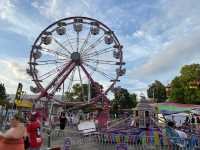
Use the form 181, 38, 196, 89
0, 112, 43, 150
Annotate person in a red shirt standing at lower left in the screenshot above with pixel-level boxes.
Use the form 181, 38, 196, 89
27, 112, 43, 150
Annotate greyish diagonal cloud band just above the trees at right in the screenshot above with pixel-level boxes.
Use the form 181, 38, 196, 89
131, 24, 200, 82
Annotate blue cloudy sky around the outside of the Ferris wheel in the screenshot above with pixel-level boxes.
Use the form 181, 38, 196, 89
0, 0, 200, 96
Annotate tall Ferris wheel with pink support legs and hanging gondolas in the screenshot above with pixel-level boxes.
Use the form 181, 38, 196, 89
27, 16, 126, 126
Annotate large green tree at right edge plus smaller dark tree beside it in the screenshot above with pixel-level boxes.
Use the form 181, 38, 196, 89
147, 64, 200, 104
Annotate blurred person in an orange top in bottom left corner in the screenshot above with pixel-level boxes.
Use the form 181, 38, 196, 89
0, 114, 26, 150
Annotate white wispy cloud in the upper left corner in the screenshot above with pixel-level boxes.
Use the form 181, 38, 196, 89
0, 0, 42, 40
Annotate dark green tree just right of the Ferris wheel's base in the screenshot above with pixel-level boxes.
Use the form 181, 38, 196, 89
111, 88, 137, 112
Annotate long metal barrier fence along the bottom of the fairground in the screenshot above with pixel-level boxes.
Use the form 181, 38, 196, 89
41, 126, 200, 150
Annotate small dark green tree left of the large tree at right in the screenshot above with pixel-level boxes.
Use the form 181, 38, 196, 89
147, 80, 167, 102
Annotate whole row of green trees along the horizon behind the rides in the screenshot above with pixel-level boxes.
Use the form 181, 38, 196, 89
0, 64, 200, 108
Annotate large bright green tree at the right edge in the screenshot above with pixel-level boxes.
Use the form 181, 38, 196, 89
170, 64, 200, 104
